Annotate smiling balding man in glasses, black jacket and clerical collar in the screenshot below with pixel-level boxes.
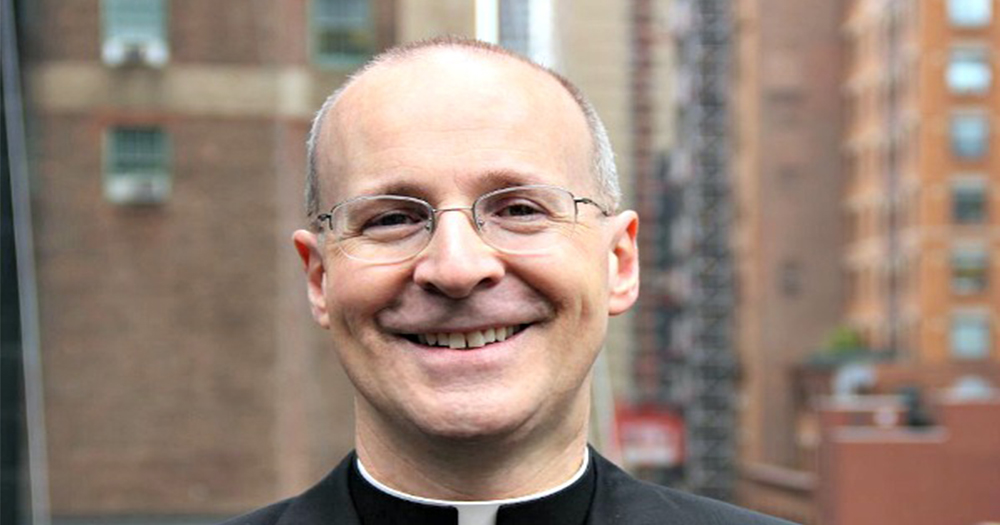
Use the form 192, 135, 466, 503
230, 39, 778, 525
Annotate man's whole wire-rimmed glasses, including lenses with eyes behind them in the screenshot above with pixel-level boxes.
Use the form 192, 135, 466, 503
316, 185, 611, 264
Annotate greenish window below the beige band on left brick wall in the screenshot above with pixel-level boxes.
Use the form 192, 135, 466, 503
104, 127, 171, 204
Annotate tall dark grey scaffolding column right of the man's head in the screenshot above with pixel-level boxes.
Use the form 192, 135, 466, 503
665, 0, 737, 500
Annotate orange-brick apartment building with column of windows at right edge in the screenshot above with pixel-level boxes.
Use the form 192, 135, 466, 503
843, 0, 1000, 368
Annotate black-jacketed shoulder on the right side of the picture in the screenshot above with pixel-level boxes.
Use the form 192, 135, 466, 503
593, 454, 791, 525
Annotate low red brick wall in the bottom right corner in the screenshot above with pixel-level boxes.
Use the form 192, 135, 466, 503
820, 400, 1000, 525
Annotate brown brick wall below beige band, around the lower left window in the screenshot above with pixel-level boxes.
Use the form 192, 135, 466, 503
35, 115, 290, 514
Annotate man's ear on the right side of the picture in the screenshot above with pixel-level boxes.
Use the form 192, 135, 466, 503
608, 210, 639, 315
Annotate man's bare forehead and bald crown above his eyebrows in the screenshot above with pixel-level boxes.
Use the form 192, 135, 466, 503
317, 49, 593, 204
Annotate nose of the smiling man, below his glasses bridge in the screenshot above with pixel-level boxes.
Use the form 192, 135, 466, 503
413, 209, 505, 299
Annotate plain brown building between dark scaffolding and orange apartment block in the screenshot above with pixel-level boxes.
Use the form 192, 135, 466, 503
733, 0, 843, 466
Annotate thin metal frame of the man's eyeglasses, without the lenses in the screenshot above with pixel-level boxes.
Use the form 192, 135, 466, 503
313, 184, 614, 264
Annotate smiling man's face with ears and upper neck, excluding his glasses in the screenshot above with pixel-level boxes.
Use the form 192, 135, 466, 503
296, 50, 638, 439
